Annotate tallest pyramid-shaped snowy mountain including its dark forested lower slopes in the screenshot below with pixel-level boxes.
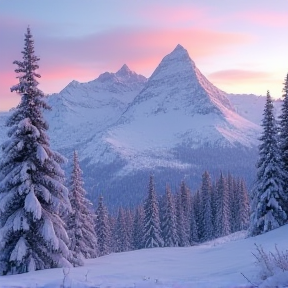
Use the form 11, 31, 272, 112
72, 45, 264, 205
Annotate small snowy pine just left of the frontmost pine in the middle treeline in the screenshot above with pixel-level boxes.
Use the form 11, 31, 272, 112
132, 205, 144, 249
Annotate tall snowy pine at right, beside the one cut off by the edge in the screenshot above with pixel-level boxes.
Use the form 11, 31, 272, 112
249, 91, 287, 236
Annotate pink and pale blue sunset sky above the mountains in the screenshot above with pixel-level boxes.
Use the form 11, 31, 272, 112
0, 0, 288, 111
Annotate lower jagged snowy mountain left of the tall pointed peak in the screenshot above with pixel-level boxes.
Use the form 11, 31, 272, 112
45, 65, 147, 149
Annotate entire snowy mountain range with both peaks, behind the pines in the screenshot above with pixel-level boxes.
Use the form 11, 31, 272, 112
0, 45, 276, 206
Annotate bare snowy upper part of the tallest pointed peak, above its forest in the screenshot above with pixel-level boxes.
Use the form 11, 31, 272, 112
100, 45, 260, 170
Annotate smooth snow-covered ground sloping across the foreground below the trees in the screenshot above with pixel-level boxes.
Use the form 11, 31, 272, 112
0, 225, 288, 288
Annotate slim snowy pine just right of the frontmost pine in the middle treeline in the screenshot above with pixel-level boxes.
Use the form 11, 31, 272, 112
162, 185, 179, 247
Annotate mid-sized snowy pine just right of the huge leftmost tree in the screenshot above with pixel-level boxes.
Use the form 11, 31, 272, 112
67, 151, 98, 260
